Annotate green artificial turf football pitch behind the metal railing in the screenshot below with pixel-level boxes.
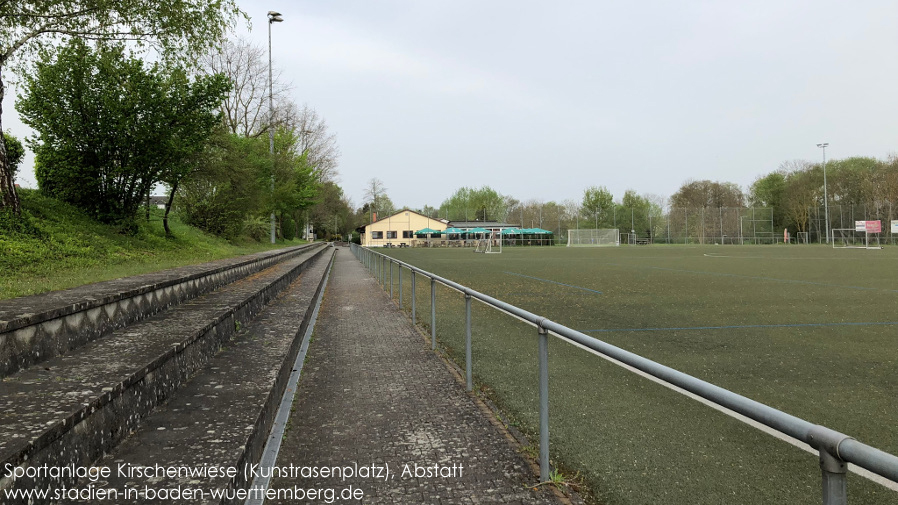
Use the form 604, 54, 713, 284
376, 245, 898, 504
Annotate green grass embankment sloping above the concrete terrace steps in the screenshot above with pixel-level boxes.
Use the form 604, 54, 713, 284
0, 189, 304, 299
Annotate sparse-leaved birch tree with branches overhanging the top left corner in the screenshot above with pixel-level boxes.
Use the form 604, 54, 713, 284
0, 0, 245, 215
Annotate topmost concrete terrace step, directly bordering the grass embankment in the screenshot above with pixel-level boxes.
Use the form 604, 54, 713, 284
0, 245, 313, 377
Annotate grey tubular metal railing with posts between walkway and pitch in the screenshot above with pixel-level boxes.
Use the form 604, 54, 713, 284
351, 244, 898, 505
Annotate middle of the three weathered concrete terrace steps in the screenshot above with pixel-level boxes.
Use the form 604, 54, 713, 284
0, 242, 327, 498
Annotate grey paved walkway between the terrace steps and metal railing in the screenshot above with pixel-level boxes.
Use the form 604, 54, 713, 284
266, 248, 558, 504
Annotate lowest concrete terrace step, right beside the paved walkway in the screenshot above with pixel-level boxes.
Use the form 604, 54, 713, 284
78, 251, 332, 504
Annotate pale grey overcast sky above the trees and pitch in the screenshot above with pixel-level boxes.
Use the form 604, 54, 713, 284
3, 0, 898, 208
